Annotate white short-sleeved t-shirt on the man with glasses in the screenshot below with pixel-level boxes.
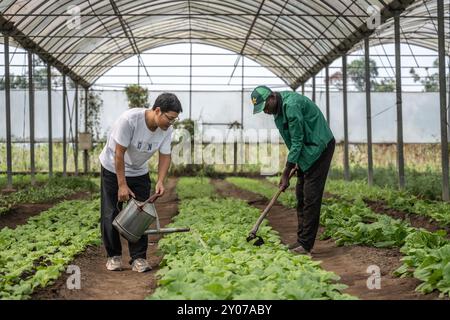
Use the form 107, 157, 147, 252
99, 108, 173, 177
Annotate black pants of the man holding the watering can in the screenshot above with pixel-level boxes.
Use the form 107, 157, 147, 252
101, 167, 150, 263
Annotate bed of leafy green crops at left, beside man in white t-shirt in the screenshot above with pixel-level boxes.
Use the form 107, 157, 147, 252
0, 199, 100, 299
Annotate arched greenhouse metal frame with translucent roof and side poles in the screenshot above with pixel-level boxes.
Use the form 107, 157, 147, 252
0, 0, 450, 201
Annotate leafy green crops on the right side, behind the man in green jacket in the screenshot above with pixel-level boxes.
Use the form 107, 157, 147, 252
227, 178, 450, 296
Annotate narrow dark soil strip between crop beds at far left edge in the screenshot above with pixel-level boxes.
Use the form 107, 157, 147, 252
0, 191, 91, 230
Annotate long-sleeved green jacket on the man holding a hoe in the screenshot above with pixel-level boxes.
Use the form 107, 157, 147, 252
274, 91, 333, 171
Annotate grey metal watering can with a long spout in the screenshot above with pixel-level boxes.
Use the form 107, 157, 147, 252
113, 194, 190, 243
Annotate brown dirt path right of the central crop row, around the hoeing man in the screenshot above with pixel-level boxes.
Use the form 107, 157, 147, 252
212, 179, 438, 300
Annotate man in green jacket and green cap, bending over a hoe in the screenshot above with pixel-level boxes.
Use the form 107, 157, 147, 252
251, 86, 335, 254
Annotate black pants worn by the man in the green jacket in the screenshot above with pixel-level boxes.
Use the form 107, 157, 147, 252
296, 139, 336, 251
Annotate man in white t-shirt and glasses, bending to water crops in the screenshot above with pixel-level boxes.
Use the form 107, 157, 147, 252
99, 93, 183, 272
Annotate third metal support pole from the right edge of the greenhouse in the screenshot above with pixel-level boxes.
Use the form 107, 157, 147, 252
364, 37, 373, 186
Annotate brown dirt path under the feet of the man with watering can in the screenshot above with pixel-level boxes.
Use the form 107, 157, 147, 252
32, 179, 177, 300
